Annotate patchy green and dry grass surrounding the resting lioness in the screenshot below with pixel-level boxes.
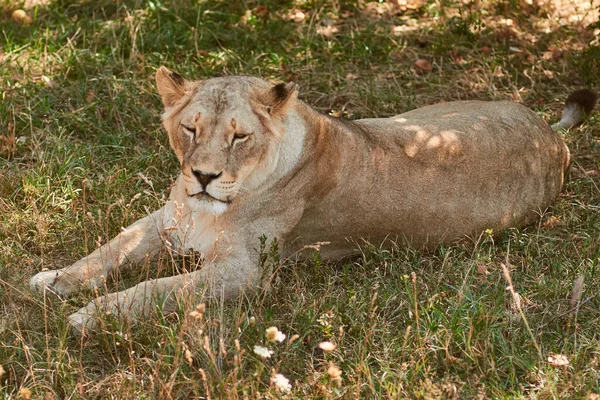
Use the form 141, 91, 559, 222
0, 0, 600, 399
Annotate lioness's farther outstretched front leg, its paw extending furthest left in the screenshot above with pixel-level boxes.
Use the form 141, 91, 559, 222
29, 207, 166, 296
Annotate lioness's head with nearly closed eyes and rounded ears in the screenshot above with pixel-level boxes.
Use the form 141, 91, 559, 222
156, 67, 298, 214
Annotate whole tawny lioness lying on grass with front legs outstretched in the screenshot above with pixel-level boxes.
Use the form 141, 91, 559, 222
30, 67, 595, 330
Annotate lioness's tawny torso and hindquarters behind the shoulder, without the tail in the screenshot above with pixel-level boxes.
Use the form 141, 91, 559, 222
286, 102, 568, 257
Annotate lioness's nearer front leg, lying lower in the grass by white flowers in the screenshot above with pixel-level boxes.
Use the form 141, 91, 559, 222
69, 250, 261, 333
